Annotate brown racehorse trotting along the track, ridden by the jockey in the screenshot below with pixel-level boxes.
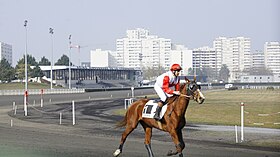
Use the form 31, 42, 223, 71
113, 79, 205, 157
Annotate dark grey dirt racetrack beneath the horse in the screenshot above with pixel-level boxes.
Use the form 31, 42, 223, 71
0, 91, 280, 157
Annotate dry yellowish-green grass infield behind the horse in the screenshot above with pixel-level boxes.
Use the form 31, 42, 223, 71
115, 89, 280, 129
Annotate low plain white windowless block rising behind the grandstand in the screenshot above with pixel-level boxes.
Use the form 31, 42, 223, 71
90, 49, 116, 67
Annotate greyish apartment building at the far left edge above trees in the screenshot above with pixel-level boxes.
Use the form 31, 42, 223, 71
0, 42, 13, 66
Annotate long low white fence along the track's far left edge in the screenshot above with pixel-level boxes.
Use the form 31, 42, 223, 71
0, 88, 85, 95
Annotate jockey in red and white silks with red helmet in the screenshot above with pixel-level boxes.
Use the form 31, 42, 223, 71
154, 64, 182, 120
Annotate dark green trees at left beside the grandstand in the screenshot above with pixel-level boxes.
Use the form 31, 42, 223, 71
0, 54, 73, 82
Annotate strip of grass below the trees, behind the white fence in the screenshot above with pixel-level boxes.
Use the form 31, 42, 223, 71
0, 82, 62, 90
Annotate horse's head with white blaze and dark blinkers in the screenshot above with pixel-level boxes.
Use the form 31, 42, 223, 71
186, 78, 205, 104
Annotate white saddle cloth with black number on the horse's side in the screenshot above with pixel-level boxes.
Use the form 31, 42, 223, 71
142, 100, 167, 119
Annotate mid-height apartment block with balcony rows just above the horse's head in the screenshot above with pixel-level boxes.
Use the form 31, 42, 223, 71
192, 47, 217, 75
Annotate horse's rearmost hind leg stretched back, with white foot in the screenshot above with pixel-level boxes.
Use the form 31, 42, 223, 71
113, 122, 138, 157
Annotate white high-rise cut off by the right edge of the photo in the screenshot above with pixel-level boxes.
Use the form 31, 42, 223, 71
264, 42, 280, 75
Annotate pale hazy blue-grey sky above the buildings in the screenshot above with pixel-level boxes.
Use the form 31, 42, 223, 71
0, 0, 280, 66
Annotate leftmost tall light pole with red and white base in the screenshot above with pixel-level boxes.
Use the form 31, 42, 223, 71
24, 20, 28, 116
